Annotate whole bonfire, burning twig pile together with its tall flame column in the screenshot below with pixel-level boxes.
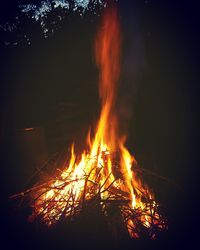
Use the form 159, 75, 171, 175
22, 4, 165, 238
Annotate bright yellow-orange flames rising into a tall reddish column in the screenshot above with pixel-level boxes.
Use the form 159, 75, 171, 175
29, 4, 164, 237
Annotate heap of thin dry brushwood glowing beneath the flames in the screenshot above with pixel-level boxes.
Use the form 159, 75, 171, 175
11, 149, 166, 238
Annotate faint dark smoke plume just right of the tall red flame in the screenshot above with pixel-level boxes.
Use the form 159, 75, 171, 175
117, 1, 145, 137
